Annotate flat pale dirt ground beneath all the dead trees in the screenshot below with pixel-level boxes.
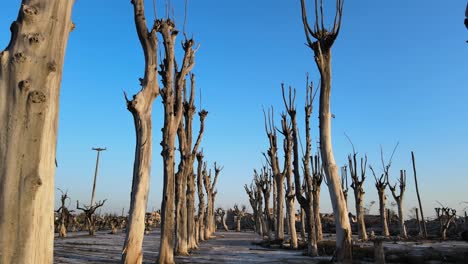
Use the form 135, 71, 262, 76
54, 229, 468, 264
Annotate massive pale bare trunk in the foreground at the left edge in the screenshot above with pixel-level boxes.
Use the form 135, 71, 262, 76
0, 0, 74, 263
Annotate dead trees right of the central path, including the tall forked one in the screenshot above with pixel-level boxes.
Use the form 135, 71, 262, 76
245, 0, 436, 262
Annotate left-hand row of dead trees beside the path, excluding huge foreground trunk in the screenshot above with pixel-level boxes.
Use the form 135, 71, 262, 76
122, 0, 226, 264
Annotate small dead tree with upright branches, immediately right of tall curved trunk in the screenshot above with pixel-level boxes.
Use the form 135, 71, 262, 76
348, 153, 367, 241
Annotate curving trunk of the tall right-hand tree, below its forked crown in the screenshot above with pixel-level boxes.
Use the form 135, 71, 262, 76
319, 53, 352, 261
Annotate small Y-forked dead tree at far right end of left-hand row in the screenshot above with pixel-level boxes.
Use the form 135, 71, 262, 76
203, 162, 223, 239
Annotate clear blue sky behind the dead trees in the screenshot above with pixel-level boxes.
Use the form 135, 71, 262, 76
0, 0, 468, 218
